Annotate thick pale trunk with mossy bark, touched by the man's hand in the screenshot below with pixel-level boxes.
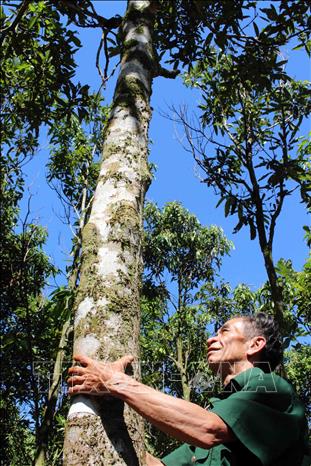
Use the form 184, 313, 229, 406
64, 0, 157, 466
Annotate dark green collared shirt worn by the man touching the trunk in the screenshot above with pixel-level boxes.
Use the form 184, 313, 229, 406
162, 367, 311, 466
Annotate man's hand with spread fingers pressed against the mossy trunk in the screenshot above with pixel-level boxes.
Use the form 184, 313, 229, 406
67, 355, 134, 396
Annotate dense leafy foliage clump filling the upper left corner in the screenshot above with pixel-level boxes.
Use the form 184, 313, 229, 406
1, 1, 95, 138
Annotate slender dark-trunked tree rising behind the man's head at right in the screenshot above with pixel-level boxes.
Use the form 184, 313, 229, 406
180, 56, 311, 330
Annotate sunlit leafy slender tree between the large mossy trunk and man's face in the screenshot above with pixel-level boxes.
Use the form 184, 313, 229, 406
143, 202, 232, 401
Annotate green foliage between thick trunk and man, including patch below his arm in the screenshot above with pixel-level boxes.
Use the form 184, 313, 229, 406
141, 202, 232, 455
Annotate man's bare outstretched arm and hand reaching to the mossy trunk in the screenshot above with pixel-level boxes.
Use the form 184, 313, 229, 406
68, 356, 235, 448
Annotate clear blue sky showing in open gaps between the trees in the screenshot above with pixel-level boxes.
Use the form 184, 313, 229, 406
21, 0, 311, 289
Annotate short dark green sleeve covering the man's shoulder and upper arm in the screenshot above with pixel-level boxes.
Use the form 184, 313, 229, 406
211, 376, 304, 465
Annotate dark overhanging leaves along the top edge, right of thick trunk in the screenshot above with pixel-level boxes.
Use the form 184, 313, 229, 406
155, 0, 311, 71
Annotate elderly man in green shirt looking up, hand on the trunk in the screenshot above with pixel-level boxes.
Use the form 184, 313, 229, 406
68, 313, 308, 466
